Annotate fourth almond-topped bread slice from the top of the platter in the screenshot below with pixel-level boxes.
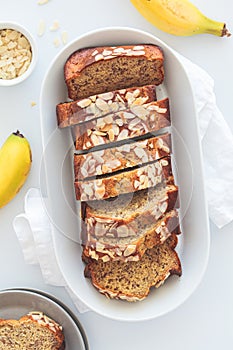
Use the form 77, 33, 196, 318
74, 133, 171, 180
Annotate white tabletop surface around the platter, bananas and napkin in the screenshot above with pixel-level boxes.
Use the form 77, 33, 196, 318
0, 0, 233, 350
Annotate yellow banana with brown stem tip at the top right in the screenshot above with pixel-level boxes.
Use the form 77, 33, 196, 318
131, 0, 231, 37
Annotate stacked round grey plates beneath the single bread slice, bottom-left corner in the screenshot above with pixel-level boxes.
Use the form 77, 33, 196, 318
0, 289, 88, 350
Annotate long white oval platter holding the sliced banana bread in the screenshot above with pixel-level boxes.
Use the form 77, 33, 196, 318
41, 27, 210, 321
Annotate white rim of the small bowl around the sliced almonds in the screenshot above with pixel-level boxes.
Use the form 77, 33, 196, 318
0, 22, 38, 86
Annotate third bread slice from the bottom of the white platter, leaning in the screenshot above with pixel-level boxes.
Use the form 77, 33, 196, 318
82, 180, 179, 239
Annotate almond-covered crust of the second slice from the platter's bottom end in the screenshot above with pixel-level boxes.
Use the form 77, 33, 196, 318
82, 209, 181, 262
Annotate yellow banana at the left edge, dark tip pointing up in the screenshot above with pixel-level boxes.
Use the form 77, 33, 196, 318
0, 131, 32, 208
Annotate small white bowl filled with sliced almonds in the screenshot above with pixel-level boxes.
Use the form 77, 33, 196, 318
0, 22, 37, 86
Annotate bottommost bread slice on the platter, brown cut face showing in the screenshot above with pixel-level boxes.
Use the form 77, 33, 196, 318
84, 235, 182, 301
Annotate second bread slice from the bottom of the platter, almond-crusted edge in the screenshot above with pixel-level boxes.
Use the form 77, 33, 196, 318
82, 209, 180, 262
